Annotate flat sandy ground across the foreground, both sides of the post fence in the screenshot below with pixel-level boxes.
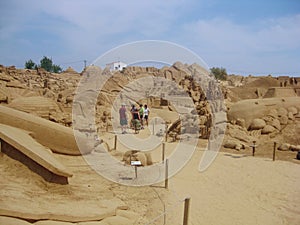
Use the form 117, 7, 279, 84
0, 107, 300, 225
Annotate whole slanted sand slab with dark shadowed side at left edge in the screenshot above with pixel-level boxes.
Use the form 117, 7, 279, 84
0, 124, 72, 184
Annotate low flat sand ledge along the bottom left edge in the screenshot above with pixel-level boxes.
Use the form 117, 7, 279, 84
0, 198, 128, 224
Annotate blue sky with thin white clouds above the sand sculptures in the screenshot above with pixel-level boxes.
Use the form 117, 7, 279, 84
0, 0, 300, 76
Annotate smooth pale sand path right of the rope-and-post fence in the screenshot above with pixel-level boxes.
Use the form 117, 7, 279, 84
97, 122, 300, 225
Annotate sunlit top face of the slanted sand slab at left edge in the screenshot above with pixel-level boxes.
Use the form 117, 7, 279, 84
0, 124, 72, 177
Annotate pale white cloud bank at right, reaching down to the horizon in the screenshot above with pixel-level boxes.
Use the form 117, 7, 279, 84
180, 14, 300, 73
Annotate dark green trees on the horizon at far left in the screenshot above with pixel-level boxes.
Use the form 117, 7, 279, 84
25, 56, 62, 73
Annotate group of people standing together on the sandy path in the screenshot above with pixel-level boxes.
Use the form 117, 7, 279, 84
119, 103, 150, 134
